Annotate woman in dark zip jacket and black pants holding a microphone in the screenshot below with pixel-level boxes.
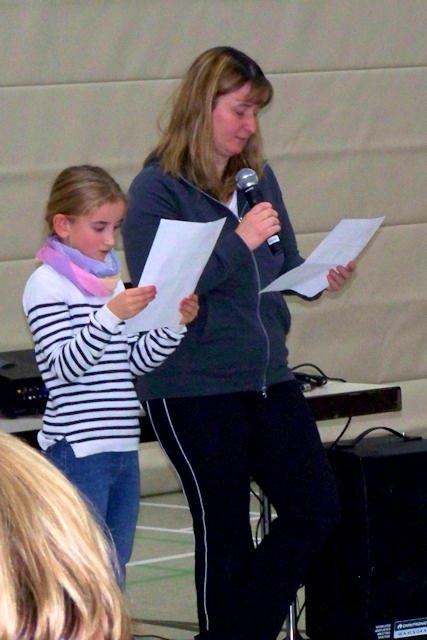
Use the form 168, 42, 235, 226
123, 47, 353, 640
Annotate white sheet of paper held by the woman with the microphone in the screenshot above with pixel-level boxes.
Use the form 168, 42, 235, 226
261, 216, 384, 298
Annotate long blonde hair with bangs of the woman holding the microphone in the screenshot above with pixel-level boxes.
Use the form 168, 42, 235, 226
144, 47, 273, 200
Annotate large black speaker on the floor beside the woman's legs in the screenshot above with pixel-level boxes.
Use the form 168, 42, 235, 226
306, 436, 427, 640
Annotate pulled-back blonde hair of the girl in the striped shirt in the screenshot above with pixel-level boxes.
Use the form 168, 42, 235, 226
45, 164, 126, 233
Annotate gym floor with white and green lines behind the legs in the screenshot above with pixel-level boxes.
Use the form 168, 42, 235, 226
126, 492, 305, 640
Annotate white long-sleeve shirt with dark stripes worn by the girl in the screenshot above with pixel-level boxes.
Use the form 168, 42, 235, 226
23, 265, 186, 457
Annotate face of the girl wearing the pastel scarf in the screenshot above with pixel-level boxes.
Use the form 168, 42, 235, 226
53, 200, 126, 262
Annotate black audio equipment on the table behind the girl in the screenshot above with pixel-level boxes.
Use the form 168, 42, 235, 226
0, 349, 47, 418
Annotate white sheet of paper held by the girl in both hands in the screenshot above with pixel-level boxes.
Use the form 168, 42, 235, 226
125, 218, 225, 333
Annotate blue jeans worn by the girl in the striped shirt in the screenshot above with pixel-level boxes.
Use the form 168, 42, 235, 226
45, 438, 139, 585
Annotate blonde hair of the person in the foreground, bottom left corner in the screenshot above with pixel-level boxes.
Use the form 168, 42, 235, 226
0, 433, 131, 640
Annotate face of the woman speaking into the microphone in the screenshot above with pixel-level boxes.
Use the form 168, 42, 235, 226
212, 82, 259, 175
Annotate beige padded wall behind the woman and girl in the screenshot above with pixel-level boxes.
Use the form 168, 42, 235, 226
0, 0, 427, 425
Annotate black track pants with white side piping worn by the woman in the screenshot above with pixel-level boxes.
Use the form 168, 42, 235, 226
147, 381, 339, 640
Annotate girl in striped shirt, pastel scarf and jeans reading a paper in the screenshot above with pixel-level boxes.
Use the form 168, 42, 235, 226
23, 166, 198, 582
